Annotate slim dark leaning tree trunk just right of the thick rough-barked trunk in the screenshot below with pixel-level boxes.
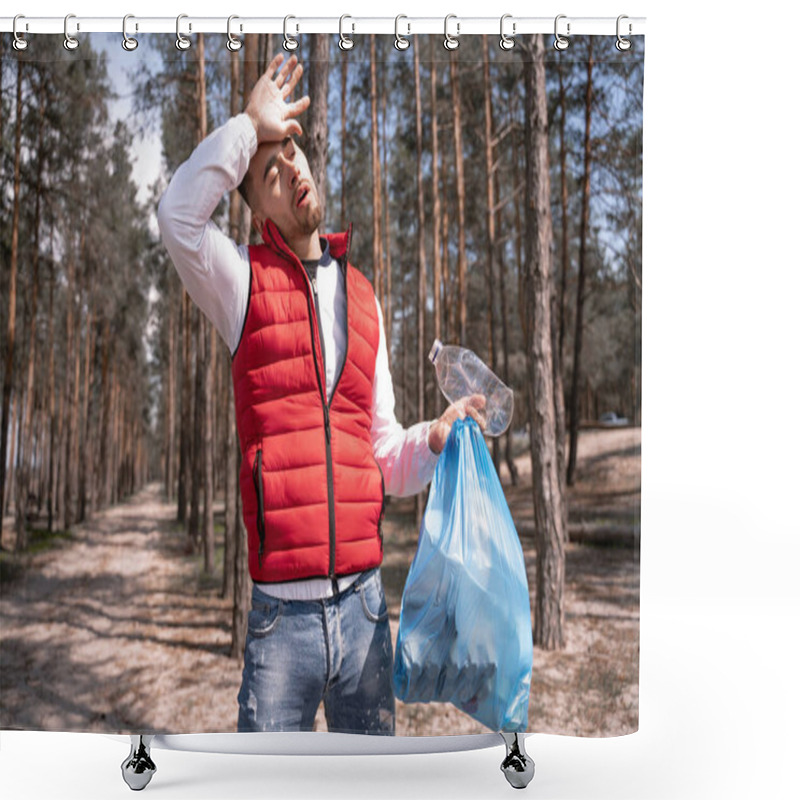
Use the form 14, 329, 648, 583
567, 36, 594, 486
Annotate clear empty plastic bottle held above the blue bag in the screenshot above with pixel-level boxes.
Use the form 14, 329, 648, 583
428, 339, 514, 436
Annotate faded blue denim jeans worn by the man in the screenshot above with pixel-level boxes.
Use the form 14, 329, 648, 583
238, 569, 395, 735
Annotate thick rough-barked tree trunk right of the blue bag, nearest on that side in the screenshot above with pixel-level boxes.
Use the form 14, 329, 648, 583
524, 35, 565, 650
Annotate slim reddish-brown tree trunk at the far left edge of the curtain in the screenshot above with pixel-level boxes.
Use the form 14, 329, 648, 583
0, 60, 22, 528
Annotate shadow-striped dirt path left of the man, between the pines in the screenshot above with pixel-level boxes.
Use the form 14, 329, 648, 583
0, 485, 241, 732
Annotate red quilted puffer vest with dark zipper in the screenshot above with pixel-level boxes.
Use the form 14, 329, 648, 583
233, 221, 384, 583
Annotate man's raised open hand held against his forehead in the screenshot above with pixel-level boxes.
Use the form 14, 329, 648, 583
244, 53, 311, 144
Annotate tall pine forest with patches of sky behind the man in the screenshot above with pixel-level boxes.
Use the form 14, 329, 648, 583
0, 29, 644, 732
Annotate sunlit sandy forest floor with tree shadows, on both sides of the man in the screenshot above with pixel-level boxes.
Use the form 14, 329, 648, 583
0, 428, 641, 736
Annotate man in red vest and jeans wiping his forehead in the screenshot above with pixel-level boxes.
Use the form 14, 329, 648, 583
158, 55, 484, 734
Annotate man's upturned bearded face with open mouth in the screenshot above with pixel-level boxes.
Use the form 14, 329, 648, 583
247, 137, 322, 244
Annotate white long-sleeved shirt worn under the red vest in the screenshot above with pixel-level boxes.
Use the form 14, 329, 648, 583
158, 114, 438, 600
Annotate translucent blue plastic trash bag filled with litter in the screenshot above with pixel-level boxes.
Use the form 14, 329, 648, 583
393, 418, 533, 733
